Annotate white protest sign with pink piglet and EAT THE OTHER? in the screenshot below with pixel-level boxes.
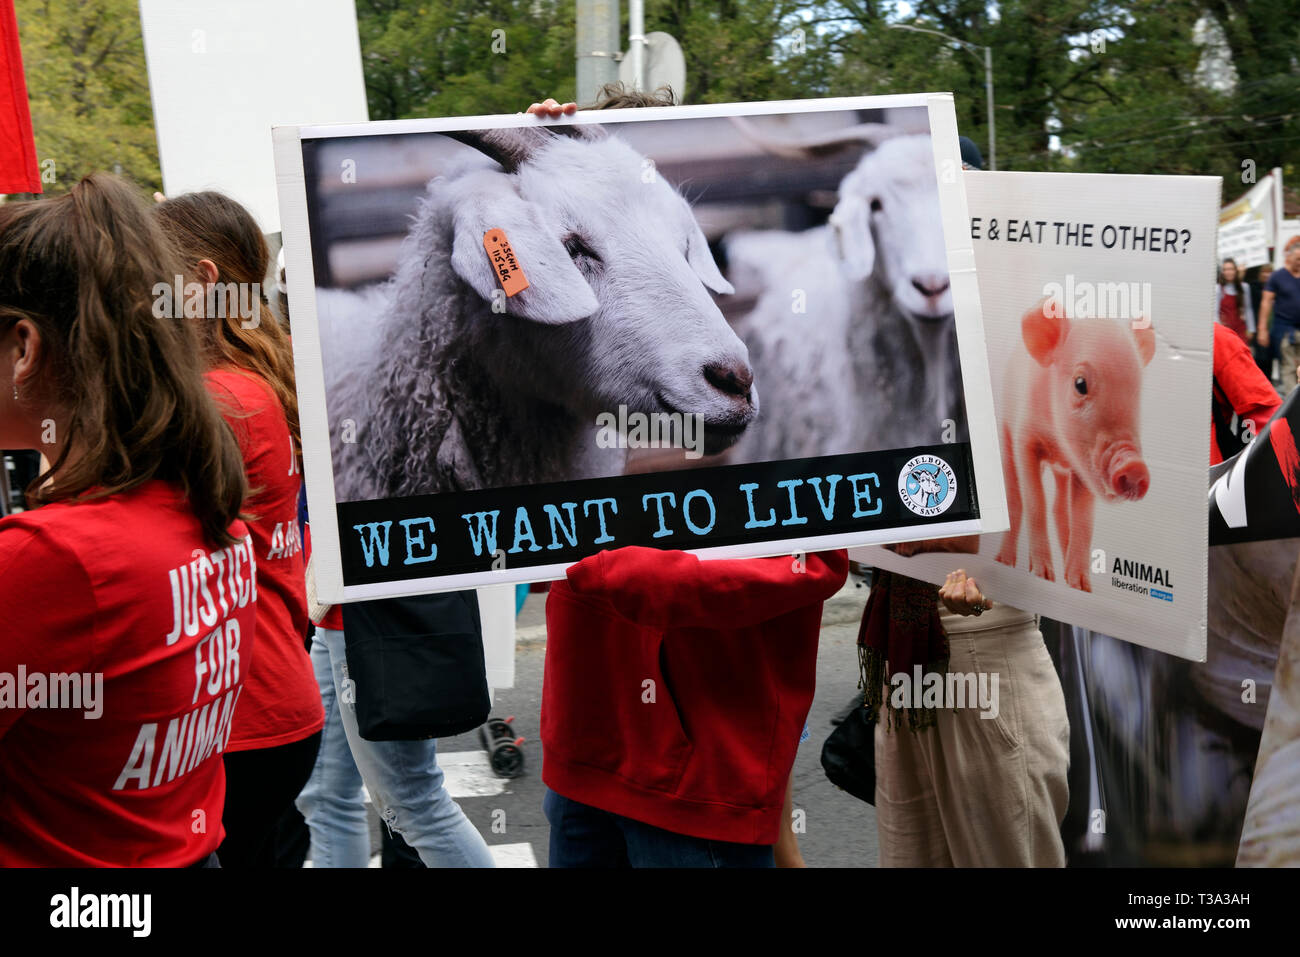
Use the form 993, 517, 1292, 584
855, 173, 1219, 661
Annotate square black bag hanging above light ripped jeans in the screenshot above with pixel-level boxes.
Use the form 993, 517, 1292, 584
342, 592, 491, 741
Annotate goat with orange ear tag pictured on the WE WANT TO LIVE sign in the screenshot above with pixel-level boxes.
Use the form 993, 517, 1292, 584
319, 125, 758, 501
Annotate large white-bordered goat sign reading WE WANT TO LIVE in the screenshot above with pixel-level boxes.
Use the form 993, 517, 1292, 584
274, 94, 1006, 601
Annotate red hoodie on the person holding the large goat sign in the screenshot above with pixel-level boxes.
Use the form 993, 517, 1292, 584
542, 547, 849, 844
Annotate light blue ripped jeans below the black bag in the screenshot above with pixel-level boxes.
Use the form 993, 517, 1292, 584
298, 628, 495, 867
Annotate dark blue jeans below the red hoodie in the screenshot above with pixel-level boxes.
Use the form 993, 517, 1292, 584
542, 791, 775, 867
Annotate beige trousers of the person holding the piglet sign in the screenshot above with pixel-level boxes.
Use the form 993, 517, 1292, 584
876, 605, 1070, 867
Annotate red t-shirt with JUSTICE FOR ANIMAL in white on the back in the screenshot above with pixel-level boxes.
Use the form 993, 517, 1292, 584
0, 481, 257, 867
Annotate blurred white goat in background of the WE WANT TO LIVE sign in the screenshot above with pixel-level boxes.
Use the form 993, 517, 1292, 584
727, 125, 967, 460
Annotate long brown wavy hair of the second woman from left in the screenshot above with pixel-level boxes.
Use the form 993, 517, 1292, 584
155, 190, 303, 471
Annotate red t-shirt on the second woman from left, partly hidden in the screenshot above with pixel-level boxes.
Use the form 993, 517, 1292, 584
207, 368, 325, 752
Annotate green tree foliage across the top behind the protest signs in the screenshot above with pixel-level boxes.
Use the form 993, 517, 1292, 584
17, 0, 1300, 200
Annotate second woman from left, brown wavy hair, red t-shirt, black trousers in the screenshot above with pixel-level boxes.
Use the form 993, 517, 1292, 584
155, 192, 325, 867
